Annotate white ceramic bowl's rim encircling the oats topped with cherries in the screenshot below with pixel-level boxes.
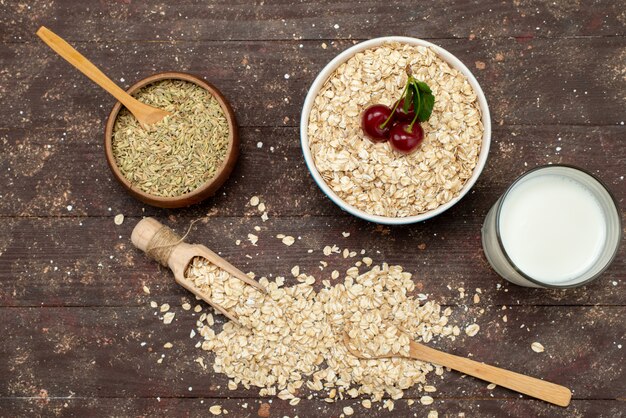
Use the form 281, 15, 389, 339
300, 36, 491, 225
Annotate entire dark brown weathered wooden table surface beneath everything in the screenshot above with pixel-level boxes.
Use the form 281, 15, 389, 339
0, 0, 626, 417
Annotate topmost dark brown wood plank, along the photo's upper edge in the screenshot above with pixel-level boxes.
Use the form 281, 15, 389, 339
0, 0, 624, 42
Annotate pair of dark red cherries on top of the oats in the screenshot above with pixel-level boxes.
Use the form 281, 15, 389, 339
361, 98, 424, 154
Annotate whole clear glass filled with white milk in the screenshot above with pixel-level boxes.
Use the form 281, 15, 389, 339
482, 165, 622, 288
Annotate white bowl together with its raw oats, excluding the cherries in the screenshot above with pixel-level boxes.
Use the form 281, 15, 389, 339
300, 36, 491, 225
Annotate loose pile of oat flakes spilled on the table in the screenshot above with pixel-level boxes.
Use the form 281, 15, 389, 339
187, 259, 461, 404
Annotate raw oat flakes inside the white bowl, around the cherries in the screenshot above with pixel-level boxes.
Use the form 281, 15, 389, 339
308, 43, 484, 217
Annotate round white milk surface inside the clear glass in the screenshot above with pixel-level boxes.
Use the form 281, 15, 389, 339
499, 174, 607, 284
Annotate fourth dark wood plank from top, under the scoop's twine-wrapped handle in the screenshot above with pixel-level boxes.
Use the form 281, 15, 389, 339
0, 216, 626, 309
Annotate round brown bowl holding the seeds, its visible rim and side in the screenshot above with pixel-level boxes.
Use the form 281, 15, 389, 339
104, 72, 239, 208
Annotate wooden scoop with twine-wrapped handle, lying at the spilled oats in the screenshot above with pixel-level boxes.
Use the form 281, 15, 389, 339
130, 218, 267, 324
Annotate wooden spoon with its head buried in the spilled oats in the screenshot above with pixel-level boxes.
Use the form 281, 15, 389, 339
343, 333, 572, 406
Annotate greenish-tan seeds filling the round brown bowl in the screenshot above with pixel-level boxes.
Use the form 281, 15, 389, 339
112, 80, 230, 197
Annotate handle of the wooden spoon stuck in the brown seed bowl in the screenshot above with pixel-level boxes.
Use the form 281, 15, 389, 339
37, 26, 139, 112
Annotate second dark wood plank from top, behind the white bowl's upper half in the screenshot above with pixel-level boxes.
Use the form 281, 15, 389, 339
0, 37, 626, 129
